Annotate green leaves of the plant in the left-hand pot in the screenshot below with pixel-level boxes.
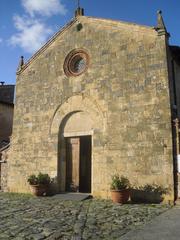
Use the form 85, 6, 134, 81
27, 172, 51, 185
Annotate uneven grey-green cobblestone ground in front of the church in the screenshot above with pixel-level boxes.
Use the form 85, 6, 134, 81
0, 193, 170, 240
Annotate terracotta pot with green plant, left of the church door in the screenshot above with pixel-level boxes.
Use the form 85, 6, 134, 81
27, 173, 51, 196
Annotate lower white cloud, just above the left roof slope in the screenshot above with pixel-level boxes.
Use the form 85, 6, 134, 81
10, 15, 53, 53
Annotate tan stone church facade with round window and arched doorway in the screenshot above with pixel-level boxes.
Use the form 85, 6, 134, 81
5, 8, 180, 201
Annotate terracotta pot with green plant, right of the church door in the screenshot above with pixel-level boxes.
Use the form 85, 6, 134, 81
111, 174, 130, 204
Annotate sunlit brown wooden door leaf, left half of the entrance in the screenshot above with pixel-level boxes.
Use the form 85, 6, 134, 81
66, 137, 80, 192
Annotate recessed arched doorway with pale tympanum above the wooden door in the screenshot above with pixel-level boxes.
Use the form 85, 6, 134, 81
59, 111, 93, 193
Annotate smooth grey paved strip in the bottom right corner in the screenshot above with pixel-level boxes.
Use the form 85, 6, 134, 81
120, 206, 180, 240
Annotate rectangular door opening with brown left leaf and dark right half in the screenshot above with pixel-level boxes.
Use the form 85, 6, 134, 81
66, 136, 92, 193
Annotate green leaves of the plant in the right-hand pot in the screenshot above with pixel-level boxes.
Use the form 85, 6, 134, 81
111, 174, 130, 190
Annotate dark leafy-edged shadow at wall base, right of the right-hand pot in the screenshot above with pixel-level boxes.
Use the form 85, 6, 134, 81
130, 184, 168, 203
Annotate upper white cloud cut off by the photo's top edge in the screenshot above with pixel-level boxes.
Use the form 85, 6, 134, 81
21, 0, 67, 17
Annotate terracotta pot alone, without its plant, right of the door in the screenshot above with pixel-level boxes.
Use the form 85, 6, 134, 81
111, 189, 130, 203
